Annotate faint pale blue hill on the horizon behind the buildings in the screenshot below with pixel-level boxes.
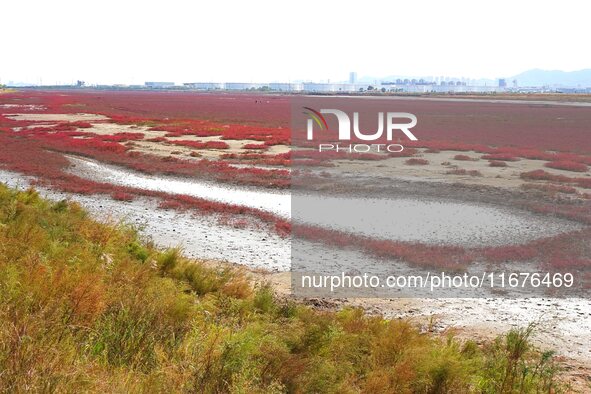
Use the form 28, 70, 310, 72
508, 69, 591, 87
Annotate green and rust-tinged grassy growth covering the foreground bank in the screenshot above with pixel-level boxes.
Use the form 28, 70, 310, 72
0, 185, 562, 393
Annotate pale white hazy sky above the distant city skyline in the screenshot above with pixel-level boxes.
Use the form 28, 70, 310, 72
0, 0, 591, 84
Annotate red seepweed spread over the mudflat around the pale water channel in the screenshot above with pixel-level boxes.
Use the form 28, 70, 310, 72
0, 92, 591, 269
